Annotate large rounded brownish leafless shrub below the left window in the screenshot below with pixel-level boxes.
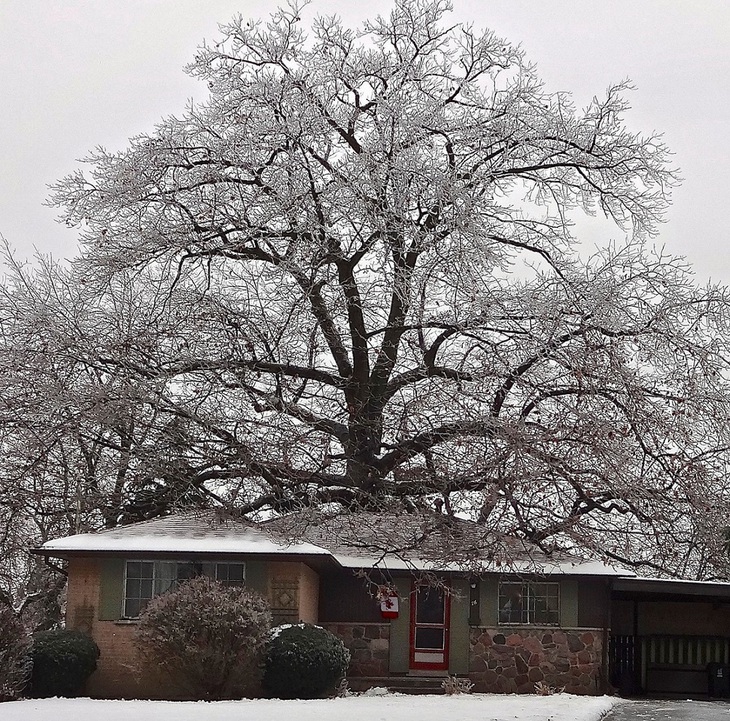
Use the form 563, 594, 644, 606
136, 576, 271, 700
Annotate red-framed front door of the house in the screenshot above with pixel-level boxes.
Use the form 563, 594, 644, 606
411, 583, 450, 671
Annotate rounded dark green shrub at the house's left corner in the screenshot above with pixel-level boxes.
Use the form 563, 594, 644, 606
31, 628, 99, 698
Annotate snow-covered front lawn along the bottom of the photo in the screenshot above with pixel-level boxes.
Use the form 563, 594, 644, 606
0, 694, 616, 721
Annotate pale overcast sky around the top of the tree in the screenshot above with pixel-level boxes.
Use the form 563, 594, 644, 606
0, 0, 730, 283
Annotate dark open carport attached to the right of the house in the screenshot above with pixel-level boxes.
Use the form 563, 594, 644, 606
609, 577, 730, 696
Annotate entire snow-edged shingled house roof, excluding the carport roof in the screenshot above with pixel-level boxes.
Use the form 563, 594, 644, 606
37, 511, 634, 577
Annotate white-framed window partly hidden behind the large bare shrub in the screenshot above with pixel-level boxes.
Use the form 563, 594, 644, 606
123, 561, 246, 618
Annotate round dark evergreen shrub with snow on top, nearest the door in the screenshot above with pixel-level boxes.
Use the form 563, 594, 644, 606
263, 623, 350, 698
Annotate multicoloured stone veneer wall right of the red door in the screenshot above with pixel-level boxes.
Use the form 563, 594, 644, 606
469, 628, 603, 694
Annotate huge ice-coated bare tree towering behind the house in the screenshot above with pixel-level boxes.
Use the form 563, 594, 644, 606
34, 0, 730, 575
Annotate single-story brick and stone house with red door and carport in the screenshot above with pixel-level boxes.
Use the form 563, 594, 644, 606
35, 511, 730, 698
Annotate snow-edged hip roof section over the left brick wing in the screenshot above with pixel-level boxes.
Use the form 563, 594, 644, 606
39, 512, 331, 556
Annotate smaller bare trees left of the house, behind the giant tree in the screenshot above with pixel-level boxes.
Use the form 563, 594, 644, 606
0, 247, 219, 612
